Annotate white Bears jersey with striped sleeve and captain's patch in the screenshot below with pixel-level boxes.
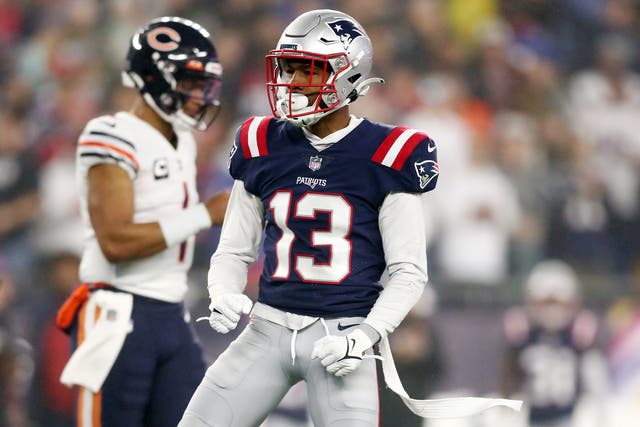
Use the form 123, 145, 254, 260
76, 112, 204, 302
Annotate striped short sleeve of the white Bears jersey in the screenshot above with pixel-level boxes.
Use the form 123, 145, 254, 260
77, 115, 140, 176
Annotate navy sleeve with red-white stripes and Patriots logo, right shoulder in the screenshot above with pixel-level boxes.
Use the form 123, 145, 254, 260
371, 126, 440, 192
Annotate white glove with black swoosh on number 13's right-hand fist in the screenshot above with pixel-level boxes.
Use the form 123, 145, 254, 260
311, 329, 374, 377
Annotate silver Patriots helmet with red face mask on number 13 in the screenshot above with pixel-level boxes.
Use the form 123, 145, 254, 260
266, 9, 384, 126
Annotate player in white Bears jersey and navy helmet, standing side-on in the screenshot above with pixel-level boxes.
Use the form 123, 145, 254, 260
58, 17, 228, 427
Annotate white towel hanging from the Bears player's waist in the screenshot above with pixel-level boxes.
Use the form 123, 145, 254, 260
60, 289, 133, 393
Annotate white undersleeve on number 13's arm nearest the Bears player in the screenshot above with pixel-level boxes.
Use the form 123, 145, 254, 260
208, 180, 264, 296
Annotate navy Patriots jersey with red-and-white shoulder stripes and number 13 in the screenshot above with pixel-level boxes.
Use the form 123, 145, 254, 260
229, 117, 439, 318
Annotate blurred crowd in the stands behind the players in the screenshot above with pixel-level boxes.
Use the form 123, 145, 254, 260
0, 0, 640, 427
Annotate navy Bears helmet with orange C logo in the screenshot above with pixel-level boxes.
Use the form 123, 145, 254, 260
122, 17, 222, 130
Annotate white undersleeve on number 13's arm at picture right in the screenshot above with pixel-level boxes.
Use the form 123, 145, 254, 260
364, 193, 427, 338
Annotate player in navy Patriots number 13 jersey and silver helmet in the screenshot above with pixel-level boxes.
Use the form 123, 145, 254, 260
179, 10, 439, 427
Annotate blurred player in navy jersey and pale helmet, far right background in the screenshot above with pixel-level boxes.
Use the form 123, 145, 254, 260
502, 260, 606, 427
